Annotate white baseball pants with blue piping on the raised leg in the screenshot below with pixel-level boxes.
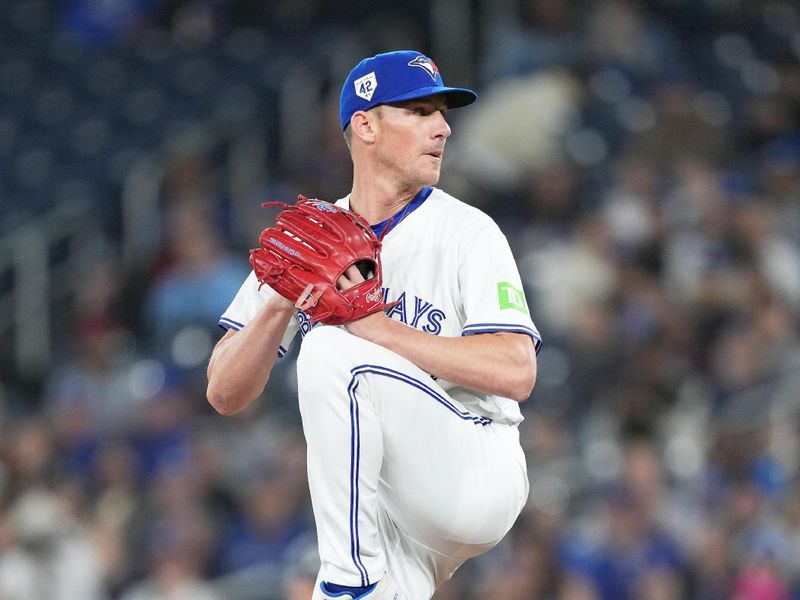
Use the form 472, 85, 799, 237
297, 326, 528, 600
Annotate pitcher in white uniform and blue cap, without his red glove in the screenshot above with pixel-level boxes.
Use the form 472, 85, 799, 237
208, 51, 540, 600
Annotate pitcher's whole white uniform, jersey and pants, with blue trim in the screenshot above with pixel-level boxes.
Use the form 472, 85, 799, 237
219, 188, 539, 600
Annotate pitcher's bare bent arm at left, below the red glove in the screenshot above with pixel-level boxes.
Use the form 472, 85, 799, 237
206, 297, 293, 415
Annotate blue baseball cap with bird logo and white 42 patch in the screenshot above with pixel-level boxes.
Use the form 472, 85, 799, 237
339, 50, 478, 131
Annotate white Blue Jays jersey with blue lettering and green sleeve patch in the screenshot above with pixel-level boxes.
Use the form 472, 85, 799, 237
219, 188, 541, 422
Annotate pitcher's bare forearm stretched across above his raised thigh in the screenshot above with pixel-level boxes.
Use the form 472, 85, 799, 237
347, 315, 536, 402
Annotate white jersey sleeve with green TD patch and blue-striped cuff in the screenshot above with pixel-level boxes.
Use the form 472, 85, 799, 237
458, 221, 542, 353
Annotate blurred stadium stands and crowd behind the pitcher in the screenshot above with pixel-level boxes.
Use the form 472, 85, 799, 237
0, 0, 800, 600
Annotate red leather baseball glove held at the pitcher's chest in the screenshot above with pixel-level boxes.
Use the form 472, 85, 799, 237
250, 196, 392, 325
